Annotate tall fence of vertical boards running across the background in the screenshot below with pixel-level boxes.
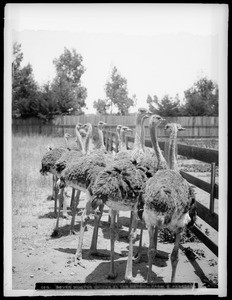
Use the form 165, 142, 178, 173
12, 115, 218, 139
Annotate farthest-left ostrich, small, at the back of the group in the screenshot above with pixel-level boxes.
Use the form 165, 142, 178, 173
40, 133, 71, 215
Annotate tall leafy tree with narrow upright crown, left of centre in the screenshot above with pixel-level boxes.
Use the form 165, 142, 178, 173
51, 48, 87, 114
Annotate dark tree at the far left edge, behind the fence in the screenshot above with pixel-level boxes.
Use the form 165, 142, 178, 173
12, 43, 39, 118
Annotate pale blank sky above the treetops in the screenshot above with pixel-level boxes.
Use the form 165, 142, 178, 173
5, 3, 227, 113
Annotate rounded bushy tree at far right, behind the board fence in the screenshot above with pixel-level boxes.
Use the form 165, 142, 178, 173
184, 77, 219, 116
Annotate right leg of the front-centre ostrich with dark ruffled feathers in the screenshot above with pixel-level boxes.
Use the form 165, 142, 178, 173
125, 212, 137, 282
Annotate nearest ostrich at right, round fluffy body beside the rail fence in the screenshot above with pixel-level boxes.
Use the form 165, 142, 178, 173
143, 124, 196, 282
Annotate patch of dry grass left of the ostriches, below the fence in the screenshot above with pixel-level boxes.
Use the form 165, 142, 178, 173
12, 135, 67, 214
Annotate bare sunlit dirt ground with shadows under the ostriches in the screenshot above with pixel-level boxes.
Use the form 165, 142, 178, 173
12, 179, 218, 290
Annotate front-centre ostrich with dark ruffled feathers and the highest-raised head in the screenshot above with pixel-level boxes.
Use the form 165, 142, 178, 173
89, 110, 155, 281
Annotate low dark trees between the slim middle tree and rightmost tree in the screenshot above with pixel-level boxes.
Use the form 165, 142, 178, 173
147, 94, 181, 117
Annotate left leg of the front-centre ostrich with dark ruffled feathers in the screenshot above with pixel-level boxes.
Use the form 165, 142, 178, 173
107, 209, 117, 279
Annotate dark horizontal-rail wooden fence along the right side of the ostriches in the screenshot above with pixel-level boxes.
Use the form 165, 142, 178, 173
103, 130, 218, 256
